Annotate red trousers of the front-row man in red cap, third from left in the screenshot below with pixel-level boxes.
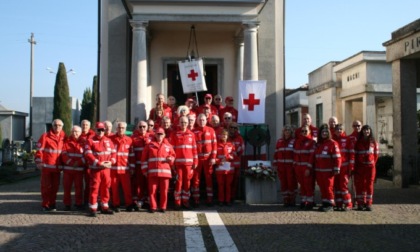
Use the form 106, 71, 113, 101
89, 169, 111, 211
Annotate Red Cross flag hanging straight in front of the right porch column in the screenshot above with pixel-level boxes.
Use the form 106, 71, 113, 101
238, 80, 267, 124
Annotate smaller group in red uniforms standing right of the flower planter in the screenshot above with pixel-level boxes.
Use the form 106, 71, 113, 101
273, 114, 379, 212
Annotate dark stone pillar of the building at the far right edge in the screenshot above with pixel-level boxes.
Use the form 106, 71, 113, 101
392, 60, 419, 188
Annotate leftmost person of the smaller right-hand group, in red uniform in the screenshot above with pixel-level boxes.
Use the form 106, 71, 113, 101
273, 125, 297, 207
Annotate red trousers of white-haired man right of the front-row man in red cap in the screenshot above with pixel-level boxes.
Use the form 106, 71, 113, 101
111, 170, 133, 207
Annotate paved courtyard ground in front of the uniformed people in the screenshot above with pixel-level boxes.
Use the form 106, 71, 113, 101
0, 177, 420, 251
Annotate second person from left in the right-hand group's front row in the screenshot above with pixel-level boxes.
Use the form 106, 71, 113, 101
293, 125, 316, 210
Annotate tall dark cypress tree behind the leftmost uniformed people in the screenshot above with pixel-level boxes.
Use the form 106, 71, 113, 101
53, 62, 72, 135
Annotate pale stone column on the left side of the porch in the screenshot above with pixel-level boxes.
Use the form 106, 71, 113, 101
130, 20, 148, 122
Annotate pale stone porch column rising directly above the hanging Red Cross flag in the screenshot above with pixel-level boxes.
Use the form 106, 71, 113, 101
243, 22, 258, 80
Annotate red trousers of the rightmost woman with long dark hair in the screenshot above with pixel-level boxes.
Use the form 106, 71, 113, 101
354, 165, 376, 206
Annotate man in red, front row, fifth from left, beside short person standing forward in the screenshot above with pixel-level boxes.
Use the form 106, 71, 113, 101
131, 121, 154, 210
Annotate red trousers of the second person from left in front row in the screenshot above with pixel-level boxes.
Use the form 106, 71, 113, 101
63, 170, 84, 206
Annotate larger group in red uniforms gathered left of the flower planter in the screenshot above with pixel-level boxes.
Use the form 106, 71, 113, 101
35, 94, 244, 217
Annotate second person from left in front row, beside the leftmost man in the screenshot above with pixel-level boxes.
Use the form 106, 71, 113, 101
61, 125, 85, 211
